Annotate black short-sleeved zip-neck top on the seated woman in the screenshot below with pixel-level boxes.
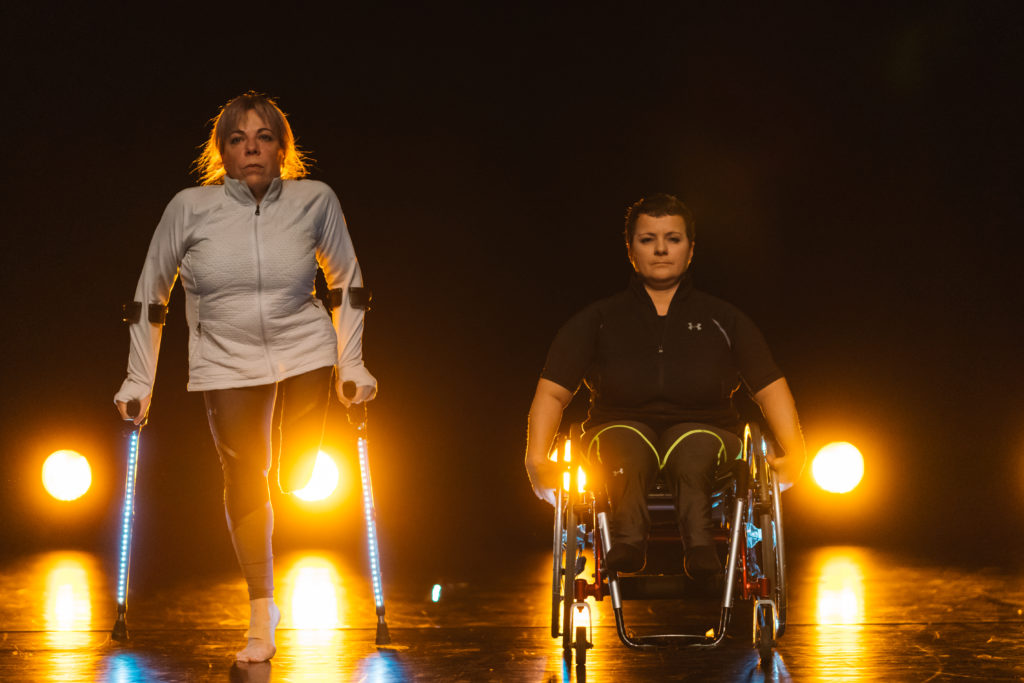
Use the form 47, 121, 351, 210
541, 275, 782, 431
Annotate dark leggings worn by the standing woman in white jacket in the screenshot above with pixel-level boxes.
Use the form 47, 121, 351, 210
204, 368, 334, 599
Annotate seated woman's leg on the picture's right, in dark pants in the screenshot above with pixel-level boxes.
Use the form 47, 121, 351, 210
659, 423, 742, 578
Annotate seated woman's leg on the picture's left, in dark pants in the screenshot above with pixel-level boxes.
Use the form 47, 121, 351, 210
584, 422, 657, 571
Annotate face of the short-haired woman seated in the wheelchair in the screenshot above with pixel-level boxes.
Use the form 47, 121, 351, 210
630, 214, 693, 289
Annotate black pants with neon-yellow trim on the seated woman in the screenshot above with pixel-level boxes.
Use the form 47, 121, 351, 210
584, 421, 742, 548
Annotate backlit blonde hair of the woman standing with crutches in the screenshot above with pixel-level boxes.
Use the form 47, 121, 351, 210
193, 90, 310, 185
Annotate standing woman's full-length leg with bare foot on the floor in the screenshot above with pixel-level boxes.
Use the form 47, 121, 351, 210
204, 384, 281, 661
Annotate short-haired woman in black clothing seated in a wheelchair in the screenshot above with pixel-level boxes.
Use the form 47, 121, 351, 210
525, 195, 805, 581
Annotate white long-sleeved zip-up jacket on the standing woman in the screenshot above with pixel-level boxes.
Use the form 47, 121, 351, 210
115, 177, 377, 401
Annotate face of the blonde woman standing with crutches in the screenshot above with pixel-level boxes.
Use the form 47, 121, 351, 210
220, 110, 285, 201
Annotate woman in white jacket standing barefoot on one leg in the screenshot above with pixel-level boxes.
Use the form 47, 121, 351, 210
115, 92, 377, 661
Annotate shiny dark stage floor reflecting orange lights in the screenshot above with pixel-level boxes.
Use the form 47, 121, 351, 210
0, 547, 1024, 683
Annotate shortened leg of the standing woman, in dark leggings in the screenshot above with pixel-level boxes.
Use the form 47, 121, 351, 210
274, 367, 334, 494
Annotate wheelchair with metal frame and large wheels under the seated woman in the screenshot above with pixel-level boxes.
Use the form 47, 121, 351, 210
550, 424, 787, 669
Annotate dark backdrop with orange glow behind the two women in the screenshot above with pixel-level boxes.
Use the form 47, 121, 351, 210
0, 1, 1024, 565
